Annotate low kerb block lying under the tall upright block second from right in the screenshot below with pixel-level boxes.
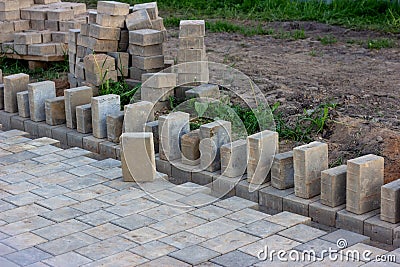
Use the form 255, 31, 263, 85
336, 209, 379, 234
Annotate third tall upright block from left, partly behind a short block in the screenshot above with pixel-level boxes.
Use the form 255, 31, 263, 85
64, 86, 93, 129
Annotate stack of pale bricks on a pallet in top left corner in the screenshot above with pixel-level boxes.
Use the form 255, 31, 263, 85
0, 0, 86, 58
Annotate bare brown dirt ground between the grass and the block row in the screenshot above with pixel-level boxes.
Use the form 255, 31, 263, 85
165, 22, 400, 182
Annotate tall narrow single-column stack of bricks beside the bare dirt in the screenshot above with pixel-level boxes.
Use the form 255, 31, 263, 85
177, 20, 209, 85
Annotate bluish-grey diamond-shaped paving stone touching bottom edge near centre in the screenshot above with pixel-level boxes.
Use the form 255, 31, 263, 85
169, 245, 220, 265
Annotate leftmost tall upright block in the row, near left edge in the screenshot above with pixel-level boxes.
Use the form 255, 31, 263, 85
4, 73, 29, 113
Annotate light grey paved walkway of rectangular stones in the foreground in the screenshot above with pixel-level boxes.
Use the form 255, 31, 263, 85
0, 130, 400, 267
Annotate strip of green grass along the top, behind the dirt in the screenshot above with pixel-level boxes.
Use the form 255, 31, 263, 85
113, 0, 400, 33
